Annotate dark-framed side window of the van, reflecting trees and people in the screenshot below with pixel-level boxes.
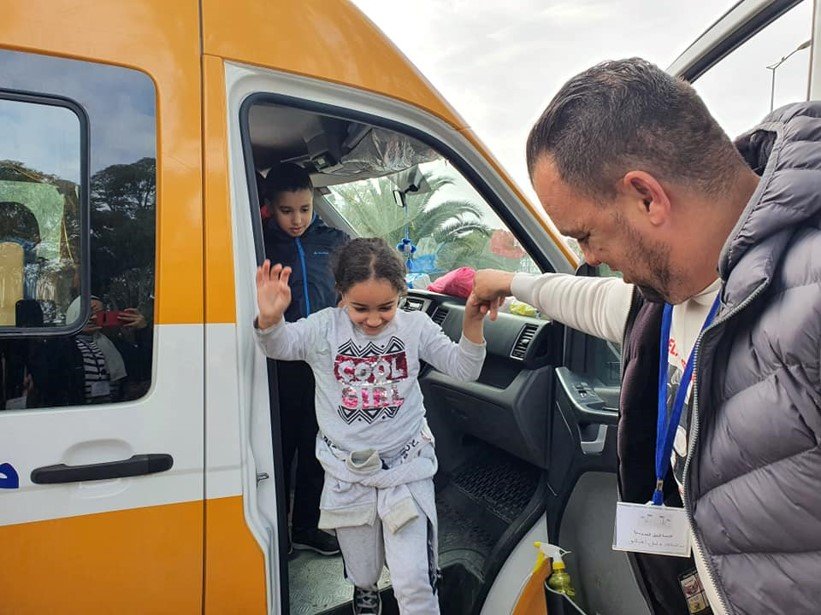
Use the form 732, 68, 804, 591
0, 51, 156, 410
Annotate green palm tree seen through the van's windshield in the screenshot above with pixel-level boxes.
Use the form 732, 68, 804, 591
333, 170, 492, 274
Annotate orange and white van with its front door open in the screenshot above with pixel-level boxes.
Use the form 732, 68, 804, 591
0, 0, 821, 615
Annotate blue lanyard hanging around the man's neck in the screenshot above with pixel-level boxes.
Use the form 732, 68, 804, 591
653, 292, 721, 506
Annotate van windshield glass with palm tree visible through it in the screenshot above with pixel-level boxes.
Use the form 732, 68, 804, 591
328, 157, 540, 280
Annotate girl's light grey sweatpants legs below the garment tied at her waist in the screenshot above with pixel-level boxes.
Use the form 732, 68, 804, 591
336, 480, 439, 615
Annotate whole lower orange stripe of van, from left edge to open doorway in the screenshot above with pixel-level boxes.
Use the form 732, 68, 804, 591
0, 496, 266, 615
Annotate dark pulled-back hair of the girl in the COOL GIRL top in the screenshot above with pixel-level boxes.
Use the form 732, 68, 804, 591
331, 237, 408, 293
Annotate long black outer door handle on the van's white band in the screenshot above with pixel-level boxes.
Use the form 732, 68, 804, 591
31, 453, 174, 485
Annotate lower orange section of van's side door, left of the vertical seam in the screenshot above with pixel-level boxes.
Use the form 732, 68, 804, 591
0, 501, 202, 615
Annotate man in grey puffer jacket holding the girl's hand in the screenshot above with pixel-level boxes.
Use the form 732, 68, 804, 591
474, 58, 821, 615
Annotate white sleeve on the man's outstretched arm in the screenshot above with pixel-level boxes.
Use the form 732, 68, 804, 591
511, 273, 633, 344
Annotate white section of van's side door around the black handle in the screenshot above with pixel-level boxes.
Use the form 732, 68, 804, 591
0, 325, 203, 528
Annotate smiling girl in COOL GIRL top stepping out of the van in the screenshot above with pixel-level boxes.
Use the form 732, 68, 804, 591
255, 239, 486, 615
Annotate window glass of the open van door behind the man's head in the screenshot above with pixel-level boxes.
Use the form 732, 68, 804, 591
693, 0, 812, 138
